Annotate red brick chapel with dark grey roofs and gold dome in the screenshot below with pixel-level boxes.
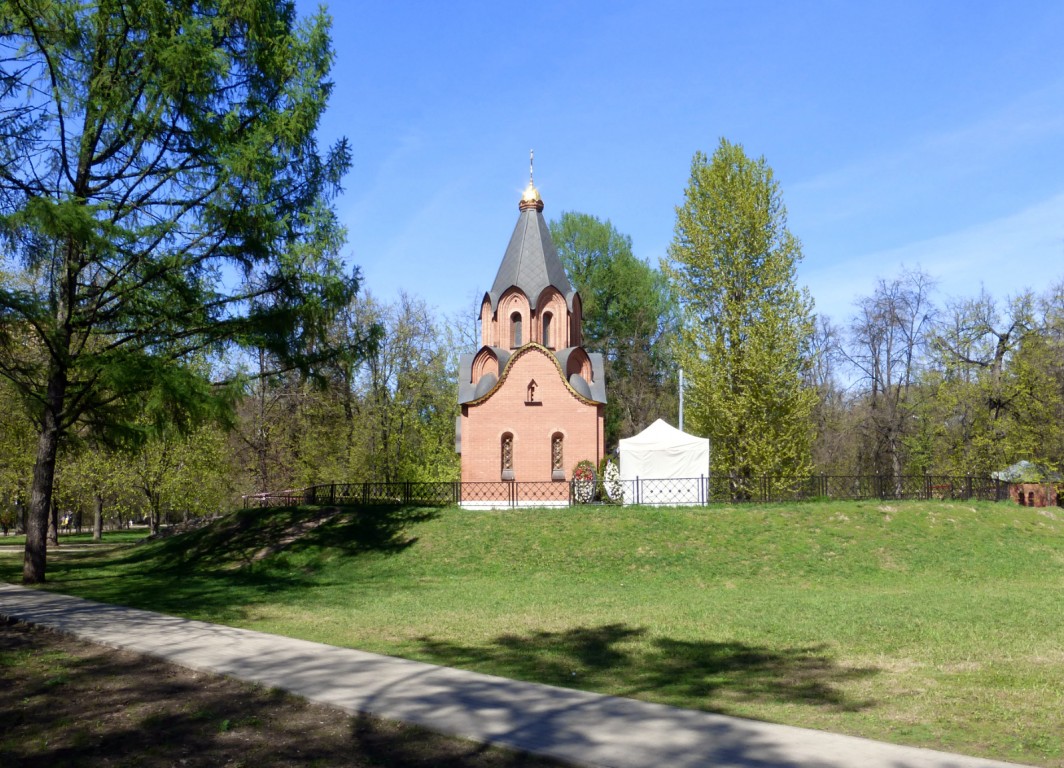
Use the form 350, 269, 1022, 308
456, 172, 605, 487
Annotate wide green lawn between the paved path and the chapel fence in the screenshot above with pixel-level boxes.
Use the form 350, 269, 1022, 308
0, 501, 1064, 766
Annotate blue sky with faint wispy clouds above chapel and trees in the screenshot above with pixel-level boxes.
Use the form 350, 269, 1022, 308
298, 0, 1064, 324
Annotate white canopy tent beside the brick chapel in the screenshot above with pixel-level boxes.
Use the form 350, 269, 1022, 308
620, 419, 710, 504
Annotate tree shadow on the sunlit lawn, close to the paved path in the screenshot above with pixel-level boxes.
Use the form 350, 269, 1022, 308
421, 623, 879, 714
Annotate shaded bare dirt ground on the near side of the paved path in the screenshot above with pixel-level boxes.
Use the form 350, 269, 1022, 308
0, 619, 562, 768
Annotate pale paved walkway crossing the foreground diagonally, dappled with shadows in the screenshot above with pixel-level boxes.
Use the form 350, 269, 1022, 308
0, 584, 1029, 768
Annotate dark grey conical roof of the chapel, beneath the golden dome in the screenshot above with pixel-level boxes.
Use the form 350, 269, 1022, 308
488, 203, 576, 310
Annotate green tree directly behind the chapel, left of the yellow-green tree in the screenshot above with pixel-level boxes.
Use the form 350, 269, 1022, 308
550, 212, 677, 450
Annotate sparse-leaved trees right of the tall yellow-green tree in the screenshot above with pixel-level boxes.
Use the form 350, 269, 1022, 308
810, 269, 1064, 477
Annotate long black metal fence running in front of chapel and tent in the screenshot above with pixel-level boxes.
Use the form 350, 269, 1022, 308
244, 474, 1009, 508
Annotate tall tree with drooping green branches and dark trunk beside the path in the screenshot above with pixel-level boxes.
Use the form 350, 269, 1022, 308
0, 0, 356, 582
